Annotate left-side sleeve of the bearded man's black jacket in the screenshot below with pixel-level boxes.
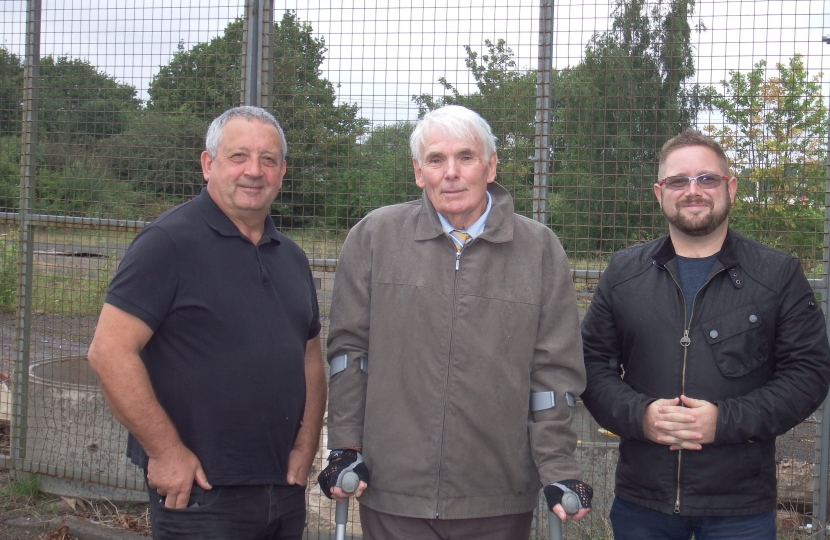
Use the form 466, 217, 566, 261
582, 259, 654, 441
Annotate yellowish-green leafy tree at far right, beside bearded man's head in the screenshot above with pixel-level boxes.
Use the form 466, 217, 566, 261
706, 55, 827, 266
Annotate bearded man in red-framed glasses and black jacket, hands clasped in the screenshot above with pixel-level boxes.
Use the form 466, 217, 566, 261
582, 130, 830, 540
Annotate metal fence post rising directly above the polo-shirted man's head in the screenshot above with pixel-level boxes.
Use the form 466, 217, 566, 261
242, 0, 274, 109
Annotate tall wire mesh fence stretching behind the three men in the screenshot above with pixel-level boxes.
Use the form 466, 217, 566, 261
0, 0, 830, 539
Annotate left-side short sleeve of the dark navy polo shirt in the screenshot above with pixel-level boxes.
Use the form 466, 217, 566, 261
104, 225, 178, 332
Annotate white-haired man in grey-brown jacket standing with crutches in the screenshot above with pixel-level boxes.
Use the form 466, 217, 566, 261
320, 106, 591, 540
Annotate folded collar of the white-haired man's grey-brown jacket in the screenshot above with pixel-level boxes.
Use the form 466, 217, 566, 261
415, 182, 515, 243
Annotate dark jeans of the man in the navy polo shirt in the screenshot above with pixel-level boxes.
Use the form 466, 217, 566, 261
147, 484, 305, 540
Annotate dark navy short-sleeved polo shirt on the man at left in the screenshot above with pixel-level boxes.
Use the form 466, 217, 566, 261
106, 189, 320, 485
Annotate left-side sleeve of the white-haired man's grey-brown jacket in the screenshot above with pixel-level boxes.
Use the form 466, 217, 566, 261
328, 223, 372, 449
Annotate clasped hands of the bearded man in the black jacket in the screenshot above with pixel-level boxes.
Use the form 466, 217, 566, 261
643, 396, 718, 450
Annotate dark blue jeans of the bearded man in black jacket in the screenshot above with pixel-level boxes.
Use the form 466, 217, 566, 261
611, 499, 775, 540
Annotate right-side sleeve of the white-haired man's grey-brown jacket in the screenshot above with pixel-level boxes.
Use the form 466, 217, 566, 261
528, 233, 585, 485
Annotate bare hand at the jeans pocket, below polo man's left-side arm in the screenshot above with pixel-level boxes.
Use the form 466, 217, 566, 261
147, 443, 211, 508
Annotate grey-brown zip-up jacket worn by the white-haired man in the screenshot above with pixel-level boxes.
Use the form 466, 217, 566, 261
328, 183, 585, 519
